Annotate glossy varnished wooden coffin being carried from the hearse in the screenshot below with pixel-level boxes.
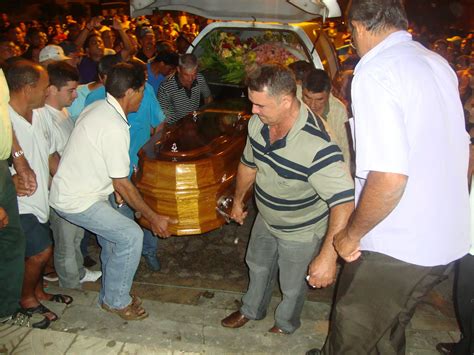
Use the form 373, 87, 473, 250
134, 99, 250, 236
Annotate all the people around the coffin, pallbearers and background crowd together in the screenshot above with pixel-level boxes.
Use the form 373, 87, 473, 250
0, 0, 474, 354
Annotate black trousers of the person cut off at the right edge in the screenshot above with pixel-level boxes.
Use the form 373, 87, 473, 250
453, 254, 474, 355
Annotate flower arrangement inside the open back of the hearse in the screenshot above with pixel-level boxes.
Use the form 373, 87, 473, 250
200, 31, 305, 84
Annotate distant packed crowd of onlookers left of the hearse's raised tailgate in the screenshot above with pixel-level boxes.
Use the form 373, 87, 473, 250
0, 13, 203, 67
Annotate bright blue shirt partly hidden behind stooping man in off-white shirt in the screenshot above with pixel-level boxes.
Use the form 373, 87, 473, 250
85, 83, 165, 177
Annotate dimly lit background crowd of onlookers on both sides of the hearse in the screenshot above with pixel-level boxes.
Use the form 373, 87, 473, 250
0, 12, 474, 117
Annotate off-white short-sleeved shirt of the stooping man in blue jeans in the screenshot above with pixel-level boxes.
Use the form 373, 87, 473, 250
50, 94, 130, 213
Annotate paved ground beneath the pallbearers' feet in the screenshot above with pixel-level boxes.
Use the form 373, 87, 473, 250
0, 204, 458, 355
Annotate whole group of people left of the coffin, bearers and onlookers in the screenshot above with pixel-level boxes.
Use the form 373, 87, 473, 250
0, 10, 212, 328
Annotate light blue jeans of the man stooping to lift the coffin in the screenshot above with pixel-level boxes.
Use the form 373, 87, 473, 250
56, 201, 143, 309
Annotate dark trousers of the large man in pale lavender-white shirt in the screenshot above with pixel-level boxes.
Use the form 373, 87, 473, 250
323, 252, 449, 355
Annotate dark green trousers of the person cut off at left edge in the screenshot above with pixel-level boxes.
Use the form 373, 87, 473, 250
0, 160, 25, 318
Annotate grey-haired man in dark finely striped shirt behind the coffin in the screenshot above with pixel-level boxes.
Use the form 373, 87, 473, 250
158, 54, 212, 124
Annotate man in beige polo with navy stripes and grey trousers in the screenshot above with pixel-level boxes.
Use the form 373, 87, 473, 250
222, 65, 354, 334
